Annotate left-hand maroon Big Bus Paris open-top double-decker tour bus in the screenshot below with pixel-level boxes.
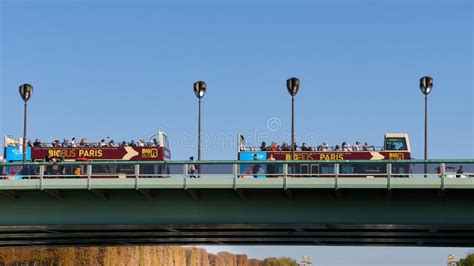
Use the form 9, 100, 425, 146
3, 131, 171, 179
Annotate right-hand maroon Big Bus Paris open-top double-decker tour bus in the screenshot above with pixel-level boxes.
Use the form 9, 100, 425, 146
237, 134, 411, 177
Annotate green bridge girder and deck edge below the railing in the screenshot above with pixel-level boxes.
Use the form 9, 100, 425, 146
0, 178, 474, 247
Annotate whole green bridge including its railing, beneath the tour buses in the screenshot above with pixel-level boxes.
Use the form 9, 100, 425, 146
0, 160, 474, 247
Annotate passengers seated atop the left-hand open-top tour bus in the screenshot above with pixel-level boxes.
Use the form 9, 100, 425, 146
28, 137, 160, 148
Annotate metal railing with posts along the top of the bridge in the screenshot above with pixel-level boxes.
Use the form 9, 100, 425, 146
0, 160, 474, 180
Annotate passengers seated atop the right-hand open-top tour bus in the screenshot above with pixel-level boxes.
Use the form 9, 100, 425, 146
252, 141, 375, 151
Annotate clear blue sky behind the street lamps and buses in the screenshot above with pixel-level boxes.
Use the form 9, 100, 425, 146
0, 0, 474, 265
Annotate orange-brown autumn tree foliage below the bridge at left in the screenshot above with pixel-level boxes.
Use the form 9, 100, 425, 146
0, 246, 297, 266
